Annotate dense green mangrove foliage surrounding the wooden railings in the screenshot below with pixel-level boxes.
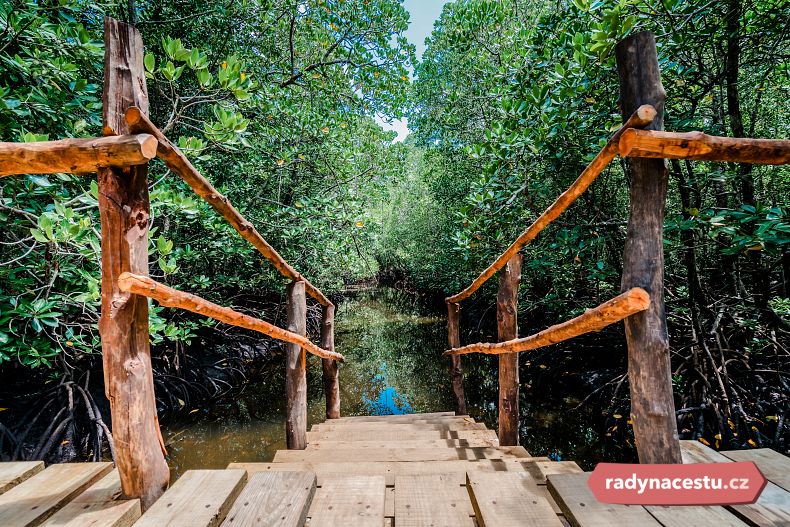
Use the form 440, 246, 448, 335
0, 0, 790, 460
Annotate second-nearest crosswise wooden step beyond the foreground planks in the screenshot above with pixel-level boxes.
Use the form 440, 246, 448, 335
274, 447, 530, 463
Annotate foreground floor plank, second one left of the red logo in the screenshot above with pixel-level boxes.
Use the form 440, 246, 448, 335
466, 472, 562, 527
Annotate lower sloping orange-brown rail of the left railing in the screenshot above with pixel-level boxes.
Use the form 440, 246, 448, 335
117, 273, 343, 360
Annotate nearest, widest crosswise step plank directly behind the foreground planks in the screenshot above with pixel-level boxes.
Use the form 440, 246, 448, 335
228, 459, 540, 486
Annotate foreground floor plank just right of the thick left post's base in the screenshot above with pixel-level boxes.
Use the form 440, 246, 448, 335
135, 470, 247, 527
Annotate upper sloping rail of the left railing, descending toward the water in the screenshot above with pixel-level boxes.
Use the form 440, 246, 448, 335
126, 108, 332, 306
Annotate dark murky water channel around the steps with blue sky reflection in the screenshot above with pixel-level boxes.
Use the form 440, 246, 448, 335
164, 288, 611, 476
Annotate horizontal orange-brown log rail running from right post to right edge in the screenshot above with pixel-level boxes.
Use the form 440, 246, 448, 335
619, 130, 790, 165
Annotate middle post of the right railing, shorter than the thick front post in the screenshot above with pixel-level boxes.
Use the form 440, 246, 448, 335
496, 254, 522, 446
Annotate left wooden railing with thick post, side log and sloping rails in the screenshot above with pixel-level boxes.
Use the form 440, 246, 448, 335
0, 18, 343, 508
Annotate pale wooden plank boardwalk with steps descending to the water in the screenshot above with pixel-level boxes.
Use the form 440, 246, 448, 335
0, 413, 790, 527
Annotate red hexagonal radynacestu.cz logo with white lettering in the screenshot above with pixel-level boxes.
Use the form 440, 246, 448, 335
588, 461, 766, 505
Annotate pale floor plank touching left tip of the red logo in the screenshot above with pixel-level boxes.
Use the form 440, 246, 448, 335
548, 473, 661, 527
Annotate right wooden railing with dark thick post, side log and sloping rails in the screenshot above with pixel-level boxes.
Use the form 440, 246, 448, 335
445, 32, 790, 463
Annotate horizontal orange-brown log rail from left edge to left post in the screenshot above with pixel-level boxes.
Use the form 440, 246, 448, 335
0, 134, 157, 177
